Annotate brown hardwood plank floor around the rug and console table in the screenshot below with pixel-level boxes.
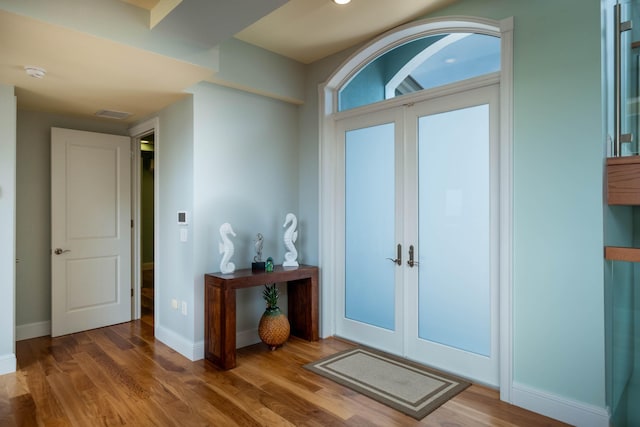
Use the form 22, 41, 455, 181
0, 315, 564, 427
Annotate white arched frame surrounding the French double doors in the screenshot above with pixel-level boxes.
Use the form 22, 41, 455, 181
318, 17, 513, 402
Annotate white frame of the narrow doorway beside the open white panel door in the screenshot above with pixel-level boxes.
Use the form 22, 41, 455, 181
129, 117, 160, 325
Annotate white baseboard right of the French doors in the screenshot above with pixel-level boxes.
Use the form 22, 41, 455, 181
511, 383, 609, 427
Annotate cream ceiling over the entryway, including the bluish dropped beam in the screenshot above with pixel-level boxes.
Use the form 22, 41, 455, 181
0, 0, 455, 122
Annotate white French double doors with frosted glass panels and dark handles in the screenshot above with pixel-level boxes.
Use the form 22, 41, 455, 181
336, 85, 499, 385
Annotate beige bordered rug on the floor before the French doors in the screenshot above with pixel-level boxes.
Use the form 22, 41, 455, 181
304, 347, 470, 420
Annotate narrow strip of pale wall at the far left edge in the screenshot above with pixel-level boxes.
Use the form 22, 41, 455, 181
0, 84, 16, 374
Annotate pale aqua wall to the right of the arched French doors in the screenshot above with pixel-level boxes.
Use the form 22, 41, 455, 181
302, 0, 605, 408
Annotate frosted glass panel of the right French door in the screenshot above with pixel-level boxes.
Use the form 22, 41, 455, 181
418, 105, 491, 356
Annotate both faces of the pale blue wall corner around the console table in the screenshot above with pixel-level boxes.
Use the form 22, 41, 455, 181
155, 83, 302, 352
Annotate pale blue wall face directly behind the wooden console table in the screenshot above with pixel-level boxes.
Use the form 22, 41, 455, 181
192, 83, 300, 344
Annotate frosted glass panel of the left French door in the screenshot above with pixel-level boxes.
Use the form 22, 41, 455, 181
345, 123, 396, 330
